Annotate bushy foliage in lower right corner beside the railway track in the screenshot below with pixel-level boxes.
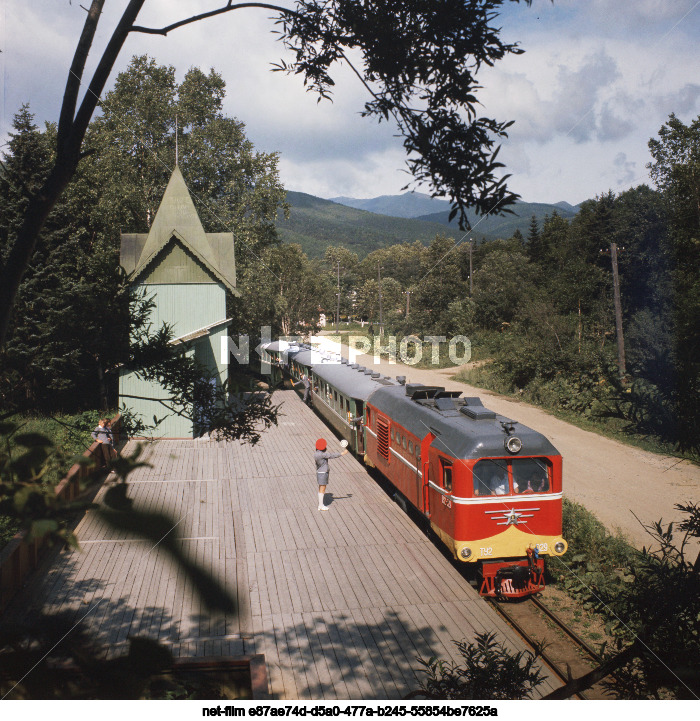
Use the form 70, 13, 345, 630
546, 503, 700, 699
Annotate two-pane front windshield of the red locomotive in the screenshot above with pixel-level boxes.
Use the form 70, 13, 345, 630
472, 458, 550, 496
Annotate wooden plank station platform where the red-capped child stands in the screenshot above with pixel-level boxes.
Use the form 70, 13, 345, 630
5, 391, 558, 700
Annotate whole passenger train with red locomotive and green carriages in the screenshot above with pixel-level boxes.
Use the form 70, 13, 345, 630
261, 341, 567, 598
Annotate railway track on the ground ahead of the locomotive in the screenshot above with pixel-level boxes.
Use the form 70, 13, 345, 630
489, 597, 614, 700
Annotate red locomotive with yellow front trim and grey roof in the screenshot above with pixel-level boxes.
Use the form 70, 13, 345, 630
365, 384, 567, 597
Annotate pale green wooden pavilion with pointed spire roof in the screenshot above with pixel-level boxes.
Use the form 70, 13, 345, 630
119, 166, 238, 438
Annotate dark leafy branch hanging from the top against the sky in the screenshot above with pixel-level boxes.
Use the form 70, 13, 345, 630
279, 0, 529, 228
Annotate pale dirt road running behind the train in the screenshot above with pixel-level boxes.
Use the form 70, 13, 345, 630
332, 346, 700, 560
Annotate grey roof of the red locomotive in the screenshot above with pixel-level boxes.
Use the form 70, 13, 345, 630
369, 383, 559, 458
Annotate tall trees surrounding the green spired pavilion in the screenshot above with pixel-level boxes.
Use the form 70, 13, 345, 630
0, 56, 284, 441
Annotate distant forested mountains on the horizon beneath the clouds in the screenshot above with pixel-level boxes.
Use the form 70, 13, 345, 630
288, 191, 578, 258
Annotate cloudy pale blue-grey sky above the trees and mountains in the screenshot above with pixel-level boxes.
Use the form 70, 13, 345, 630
0, 0, 700, 203
